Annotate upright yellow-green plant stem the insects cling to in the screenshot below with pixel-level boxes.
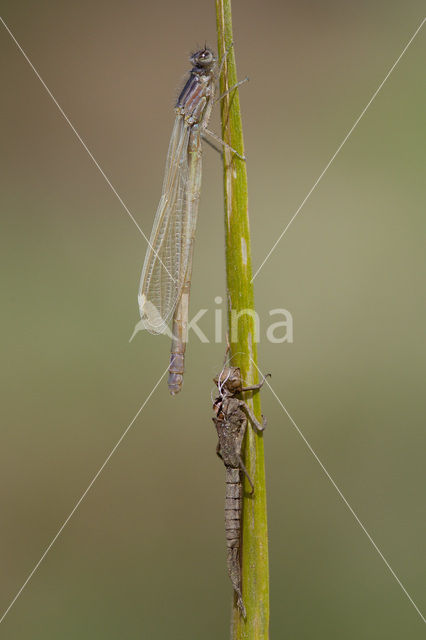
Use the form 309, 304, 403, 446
216, 0, 269, 640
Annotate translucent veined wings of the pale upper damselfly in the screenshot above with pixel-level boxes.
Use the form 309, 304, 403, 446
138, 115, 192, 333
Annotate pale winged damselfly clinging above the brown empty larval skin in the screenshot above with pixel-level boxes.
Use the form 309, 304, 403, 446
138, 47, 241, 395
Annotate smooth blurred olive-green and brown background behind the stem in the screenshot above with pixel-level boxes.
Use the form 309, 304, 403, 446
0, 0, 426, 640
